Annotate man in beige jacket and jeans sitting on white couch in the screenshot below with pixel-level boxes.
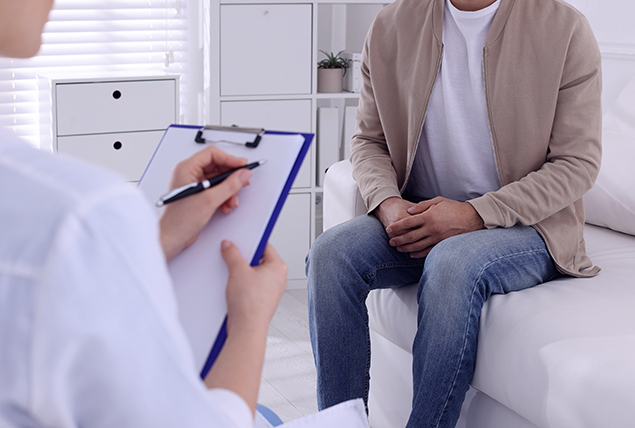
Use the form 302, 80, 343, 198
307, 0, 601, 428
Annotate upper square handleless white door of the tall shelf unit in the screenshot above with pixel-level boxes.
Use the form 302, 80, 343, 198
220, 4, 313, 95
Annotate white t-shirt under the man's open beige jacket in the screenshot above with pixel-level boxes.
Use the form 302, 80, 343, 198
407, 0, 501, 201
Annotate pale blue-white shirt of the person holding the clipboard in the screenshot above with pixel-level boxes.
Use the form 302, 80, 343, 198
0, 129, 253, 428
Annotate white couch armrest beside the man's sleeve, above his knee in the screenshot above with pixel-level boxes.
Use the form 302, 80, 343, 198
323, 160, 366, 230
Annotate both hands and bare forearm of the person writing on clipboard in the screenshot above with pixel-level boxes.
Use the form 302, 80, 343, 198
160, 147, 287, 414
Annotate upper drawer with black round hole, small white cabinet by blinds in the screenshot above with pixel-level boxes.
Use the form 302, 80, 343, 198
55, 80, 176, 135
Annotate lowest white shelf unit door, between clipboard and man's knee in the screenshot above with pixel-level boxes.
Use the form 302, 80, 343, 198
269, 193, 311, 280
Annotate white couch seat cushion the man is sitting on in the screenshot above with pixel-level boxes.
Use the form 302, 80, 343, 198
367, 225, 635, 428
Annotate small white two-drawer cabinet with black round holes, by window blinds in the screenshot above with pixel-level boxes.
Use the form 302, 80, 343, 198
40, 75, 179, 182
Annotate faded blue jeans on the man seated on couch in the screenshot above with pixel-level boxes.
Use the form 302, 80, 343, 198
306, 216, 558, 428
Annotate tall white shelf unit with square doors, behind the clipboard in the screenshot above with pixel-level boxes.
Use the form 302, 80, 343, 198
211, 0, 387, 288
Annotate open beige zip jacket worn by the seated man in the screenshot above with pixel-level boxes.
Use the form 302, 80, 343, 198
351, 0, 602, 276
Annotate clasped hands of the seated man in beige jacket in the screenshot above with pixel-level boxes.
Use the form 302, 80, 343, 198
386, 197, 485, 258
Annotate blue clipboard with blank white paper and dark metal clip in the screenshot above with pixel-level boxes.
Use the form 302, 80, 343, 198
138, 125, 313, 378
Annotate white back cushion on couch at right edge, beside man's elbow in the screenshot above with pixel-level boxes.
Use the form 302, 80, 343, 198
584, 79, 635, 235
